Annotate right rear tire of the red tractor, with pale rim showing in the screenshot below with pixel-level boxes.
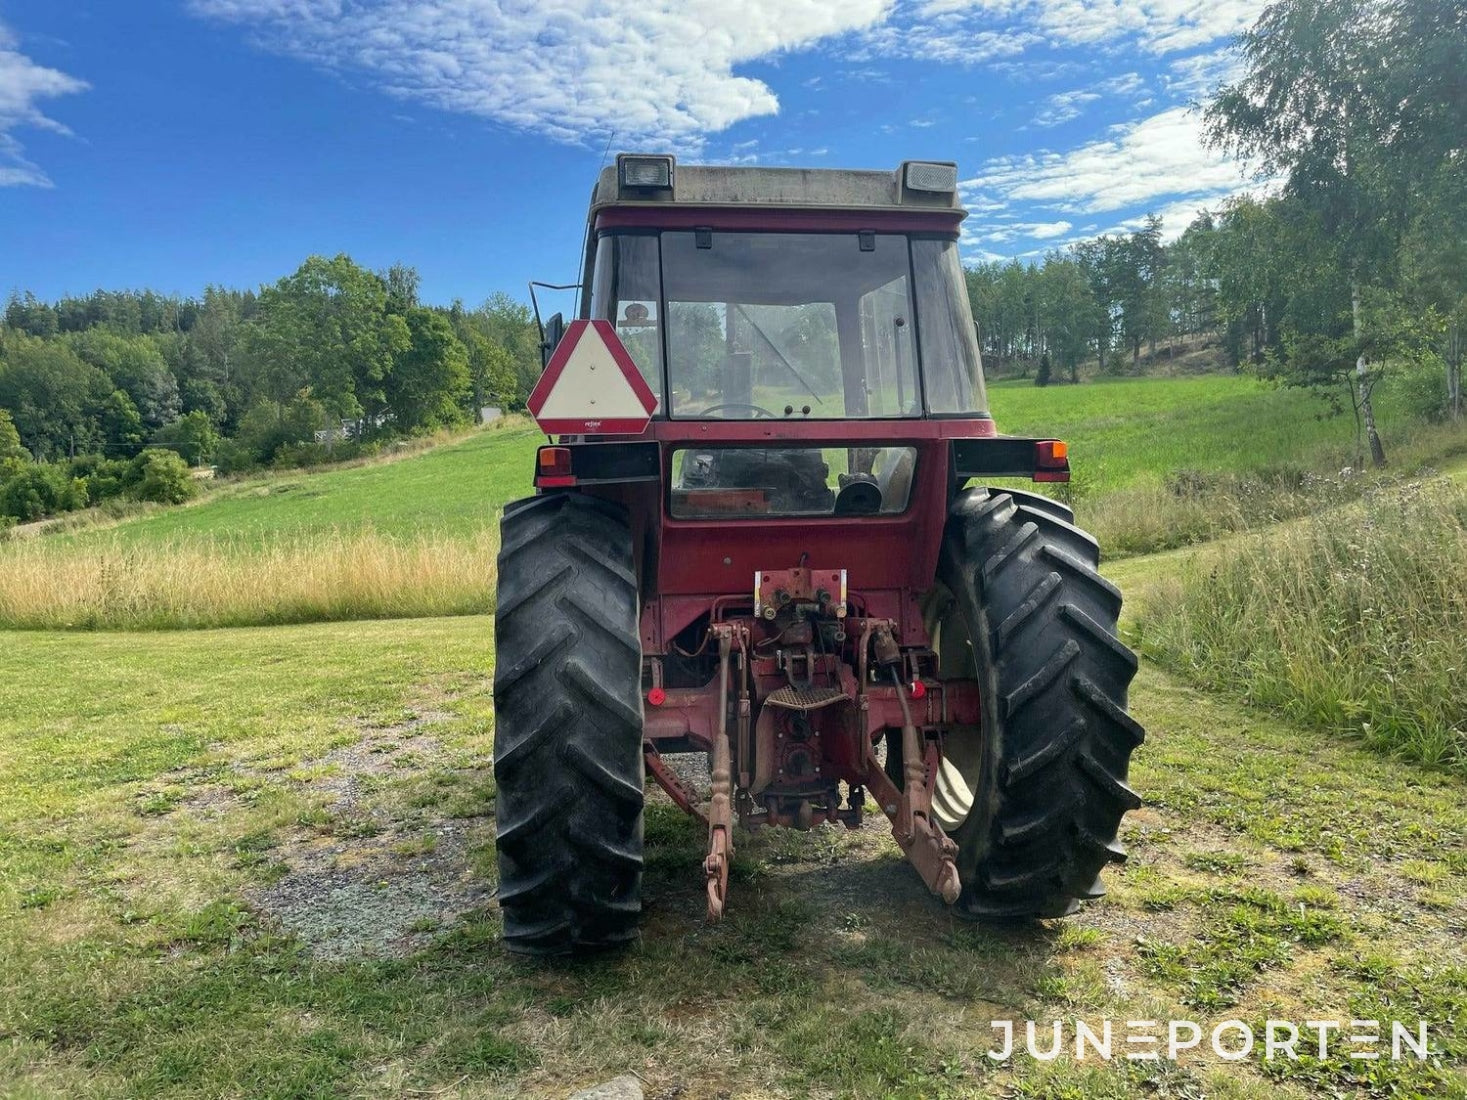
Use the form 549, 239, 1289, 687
903, 488, 1144, 918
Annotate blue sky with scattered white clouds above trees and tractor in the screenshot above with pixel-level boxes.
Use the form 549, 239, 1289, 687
0, 0, 1262, 304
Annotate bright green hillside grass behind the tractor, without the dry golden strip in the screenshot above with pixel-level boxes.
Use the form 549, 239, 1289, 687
20, 375, 1467, 556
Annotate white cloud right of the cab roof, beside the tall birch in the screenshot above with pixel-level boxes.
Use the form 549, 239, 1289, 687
962, 107, 1241, 214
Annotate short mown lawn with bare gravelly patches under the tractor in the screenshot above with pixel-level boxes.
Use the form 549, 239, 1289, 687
0, 617, 1467, 1099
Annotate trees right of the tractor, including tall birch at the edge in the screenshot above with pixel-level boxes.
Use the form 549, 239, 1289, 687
968, 0, 1467, 463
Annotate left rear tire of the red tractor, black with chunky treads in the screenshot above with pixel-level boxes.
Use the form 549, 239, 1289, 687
494, 493, 644, 955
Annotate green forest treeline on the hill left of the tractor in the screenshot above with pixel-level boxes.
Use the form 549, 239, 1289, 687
0, 265, 540, 522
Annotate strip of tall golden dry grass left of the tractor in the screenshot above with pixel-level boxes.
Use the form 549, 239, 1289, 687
0, 529, 499, 631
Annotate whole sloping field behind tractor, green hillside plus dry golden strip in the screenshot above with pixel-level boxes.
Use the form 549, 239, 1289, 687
0, 375, 1467, 629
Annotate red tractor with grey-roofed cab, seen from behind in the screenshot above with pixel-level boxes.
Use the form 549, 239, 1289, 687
494, 155, 1143, 955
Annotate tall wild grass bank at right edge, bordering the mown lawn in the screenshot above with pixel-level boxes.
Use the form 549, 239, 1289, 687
1140, 481, 1467, 770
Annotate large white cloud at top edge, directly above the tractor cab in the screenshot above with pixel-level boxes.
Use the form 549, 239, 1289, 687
191, 0, 892, 148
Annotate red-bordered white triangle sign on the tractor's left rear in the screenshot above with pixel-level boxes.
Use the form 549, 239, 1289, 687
525, 321, 657, 436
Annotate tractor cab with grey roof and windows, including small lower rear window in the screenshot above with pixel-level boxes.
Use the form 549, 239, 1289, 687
585, 157, 987, 518
